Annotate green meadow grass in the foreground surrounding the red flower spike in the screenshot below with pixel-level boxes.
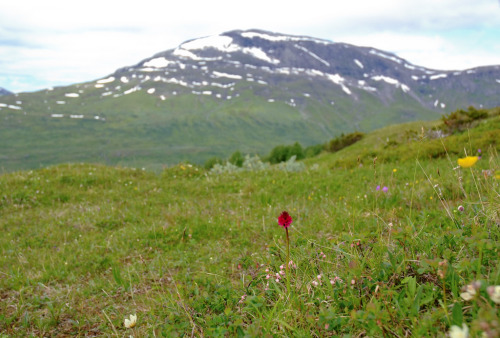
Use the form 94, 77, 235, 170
0, 113, 500, 337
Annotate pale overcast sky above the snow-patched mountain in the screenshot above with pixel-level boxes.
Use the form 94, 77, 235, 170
0, 0, 500, 92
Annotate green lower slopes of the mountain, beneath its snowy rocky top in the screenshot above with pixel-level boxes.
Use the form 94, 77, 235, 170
0, 81, 439, 171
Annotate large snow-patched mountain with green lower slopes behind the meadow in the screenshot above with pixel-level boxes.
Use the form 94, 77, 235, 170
0, 30, 500, 170
